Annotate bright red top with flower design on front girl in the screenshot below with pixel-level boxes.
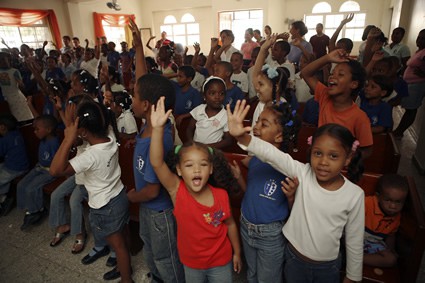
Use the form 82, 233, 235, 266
174, 180, 232, 269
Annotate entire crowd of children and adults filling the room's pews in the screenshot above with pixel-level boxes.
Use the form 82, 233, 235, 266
0, 14, 425, 283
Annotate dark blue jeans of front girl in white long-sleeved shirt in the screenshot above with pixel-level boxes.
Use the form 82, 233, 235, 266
284, 244, 341, 283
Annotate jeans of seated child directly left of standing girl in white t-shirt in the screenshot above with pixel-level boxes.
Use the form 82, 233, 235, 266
49, 175, 87, 235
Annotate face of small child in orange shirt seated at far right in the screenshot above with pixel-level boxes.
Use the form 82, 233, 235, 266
378, 187, 407, 216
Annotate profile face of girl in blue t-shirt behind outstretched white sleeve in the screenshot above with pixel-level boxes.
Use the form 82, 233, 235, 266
253, 108, 282, 144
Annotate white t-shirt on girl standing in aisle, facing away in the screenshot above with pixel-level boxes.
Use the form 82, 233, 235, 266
69, 136, 124, 209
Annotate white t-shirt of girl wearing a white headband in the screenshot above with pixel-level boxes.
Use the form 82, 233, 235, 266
190, 104, 229, 144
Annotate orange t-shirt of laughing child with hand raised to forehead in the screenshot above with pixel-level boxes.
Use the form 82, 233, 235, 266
314, 82, 373, 147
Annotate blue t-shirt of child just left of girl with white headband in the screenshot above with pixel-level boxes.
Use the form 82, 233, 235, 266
172, 81, 202, 115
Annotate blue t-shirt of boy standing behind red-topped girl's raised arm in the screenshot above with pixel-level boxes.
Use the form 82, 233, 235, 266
133, 122, 173, 211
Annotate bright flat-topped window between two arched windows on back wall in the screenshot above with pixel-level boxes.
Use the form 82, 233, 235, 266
218, 10, 263, 49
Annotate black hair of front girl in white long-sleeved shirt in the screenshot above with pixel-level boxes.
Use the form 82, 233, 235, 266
308, 124, 364, 183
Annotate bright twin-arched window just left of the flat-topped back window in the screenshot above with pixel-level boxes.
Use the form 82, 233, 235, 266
161, 13, 199, 46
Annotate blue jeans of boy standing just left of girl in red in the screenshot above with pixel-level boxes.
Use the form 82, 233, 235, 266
139, 206, 184, 283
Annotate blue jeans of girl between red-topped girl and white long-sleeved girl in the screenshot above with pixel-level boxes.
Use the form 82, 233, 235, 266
241, 215, 285, 283
